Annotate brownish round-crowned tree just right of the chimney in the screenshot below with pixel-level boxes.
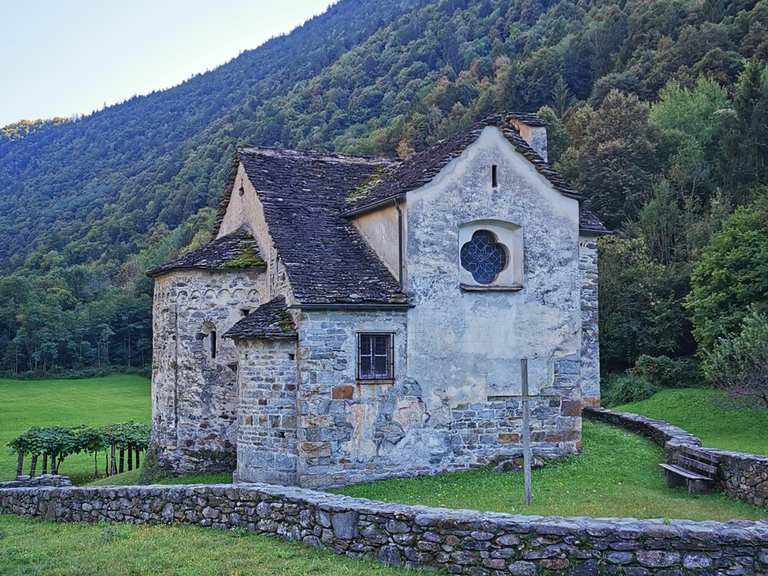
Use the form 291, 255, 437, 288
560, 90, 657, 228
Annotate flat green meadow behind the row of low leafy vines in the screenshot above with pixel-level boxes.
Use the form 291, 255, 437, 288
0, 375, 151, 483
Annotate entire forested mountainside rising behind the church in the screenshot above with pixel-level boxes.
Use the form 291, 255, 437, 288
0, 0, 768, 380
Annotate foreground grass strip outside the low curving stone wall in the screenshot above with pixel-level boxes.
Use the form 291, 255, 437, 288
0, 515, 414, 576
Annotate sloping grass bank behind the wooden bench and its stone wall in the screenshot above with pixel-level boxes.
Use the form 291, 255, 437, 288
615, 388, 768, 454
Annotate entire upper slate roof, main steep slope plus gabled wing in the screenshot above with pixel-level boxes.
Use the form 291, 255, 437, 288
207, 114, 608, 305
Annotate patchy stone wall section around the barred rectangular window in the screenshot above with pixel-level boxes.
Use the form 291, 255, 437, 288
297, 310, 414, 487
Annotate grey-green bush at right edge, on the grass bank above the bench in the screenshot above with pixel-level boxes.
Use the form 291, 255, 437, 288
704, 311, 768, 407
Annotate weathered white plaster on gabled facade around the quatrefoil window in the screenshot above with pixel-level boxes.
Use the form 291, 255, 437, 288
405, 127, 581, 409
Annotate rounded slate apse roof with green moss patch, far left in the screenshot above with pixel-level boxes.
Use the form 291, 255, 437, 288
147, 226, 265, 276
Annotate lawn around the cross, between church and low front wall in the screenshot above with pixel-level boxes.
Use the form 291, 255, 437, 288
337, 421, 768, 520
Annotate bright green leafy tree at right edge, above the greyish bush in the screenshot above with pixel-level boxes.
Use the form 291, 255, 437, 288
685, 201, 768, 352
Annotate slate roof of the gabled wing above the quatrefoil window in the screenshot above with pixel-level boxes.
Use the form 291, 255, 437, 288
347, 114, 581, 214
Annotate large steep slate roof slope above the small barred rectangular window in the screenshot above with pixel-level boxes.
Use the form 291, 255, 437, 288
236, 148, 407, 305
